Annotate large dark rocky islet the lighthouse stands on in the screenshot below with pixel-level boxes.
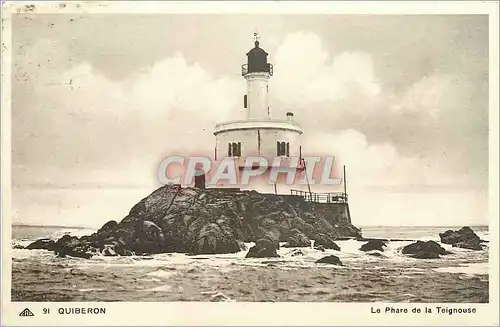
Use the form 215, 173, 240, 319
28, 185, 360, 257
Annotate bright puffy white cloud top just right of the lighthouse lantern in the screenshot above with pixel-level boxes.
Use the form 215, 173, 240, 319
273, 32, 381, 108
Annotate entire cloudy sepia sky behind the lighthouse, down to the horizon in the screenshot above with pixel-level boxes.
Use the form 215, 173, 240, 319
12, 14, 489, 227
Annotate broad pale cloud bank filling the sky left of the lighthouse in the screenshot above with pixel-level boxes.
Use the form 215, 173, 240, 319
13, 40, 244, 184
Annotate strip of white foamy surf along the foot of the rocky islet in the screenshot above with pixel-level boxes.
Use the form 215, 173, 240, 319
12, 237, 488, 278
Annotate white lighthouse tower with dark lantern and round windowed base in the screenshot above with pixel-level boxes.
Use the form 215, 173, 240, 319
214, 37, 303, 177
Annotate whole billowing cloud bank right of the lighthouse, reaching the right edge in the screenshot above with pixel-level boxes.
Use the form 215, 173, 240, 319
270, 32, 487, 191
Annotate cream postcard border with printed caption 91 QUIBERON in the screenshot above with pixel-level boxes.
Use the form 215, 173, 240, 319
1, 1, 499, 326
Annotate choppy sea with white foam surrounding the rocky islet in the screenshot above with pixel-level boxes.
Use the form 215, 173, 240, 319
11, 225, 489, 303
